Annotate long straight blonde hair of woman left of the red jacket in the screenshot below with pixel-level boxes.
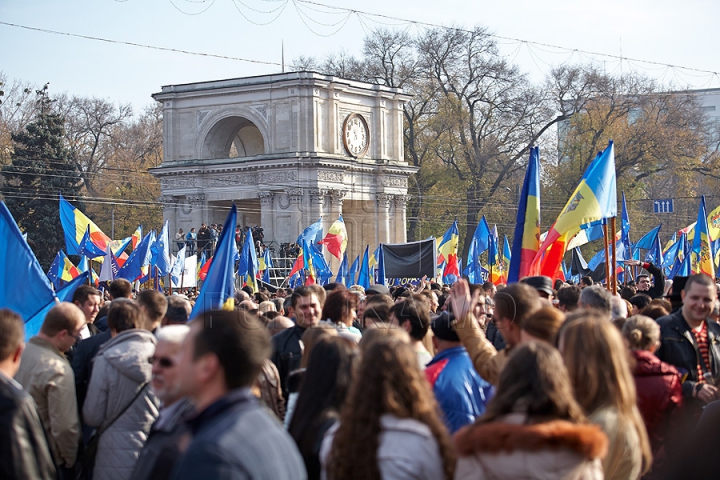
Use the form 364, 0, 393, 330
559, 310, 652, 474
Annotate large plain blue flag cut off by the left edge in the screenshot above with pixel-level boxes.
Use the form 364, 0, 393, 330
0, 202, 55, 321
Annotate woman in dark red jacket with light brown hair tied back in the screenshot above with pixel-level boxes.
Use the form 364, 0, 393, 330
622, 315, 683, 477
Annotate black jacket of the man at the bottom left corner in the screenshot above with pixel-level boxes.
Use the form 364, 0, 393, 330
0, 373, 58, 480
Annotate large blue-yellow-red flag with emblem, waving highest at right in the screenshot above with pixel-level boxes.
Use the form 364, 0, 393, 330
530, 140, 617, 278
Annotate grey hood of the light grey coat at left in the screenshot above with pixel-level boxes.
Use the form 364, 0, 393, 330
98, 329, 157, 383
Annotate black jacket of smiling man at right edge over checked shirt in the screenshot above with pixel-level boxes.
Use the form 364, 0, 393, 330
656, 309, 720, 399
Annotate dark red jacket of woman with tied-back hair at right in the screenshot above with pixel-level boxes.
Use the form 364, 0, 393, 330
631, 350, 683, 456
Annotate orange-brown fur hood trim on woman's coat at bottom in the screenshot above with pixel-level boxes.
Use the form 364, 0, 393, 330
455, 420, 608, 460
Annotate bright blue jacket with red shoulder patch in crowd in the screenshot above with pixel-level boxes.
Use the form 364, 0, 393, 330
425, 346, 495, 433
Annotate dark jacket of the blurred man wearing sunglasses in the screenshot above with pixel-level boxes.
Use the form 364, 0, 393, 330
130, 399, 195, 480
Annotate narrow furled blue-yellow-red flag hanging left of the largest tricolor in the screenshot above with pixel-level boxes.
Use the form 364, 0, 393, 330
507, 147, 540, 283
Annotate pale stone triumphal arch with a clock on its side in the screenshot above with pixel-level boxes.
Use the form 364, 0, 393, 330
151, 72, 417, 259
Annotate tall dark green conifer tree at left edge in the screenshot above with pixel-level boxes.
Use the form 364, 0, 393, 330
2, 85, 82, 269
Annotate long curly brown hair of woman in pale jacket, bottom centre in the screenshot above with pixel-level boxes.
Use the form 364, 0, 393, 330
327, 337, 455, 480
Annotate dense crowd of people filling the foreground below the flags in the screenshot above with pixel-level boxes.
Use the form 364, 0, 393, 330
0, 260, 720, 480
